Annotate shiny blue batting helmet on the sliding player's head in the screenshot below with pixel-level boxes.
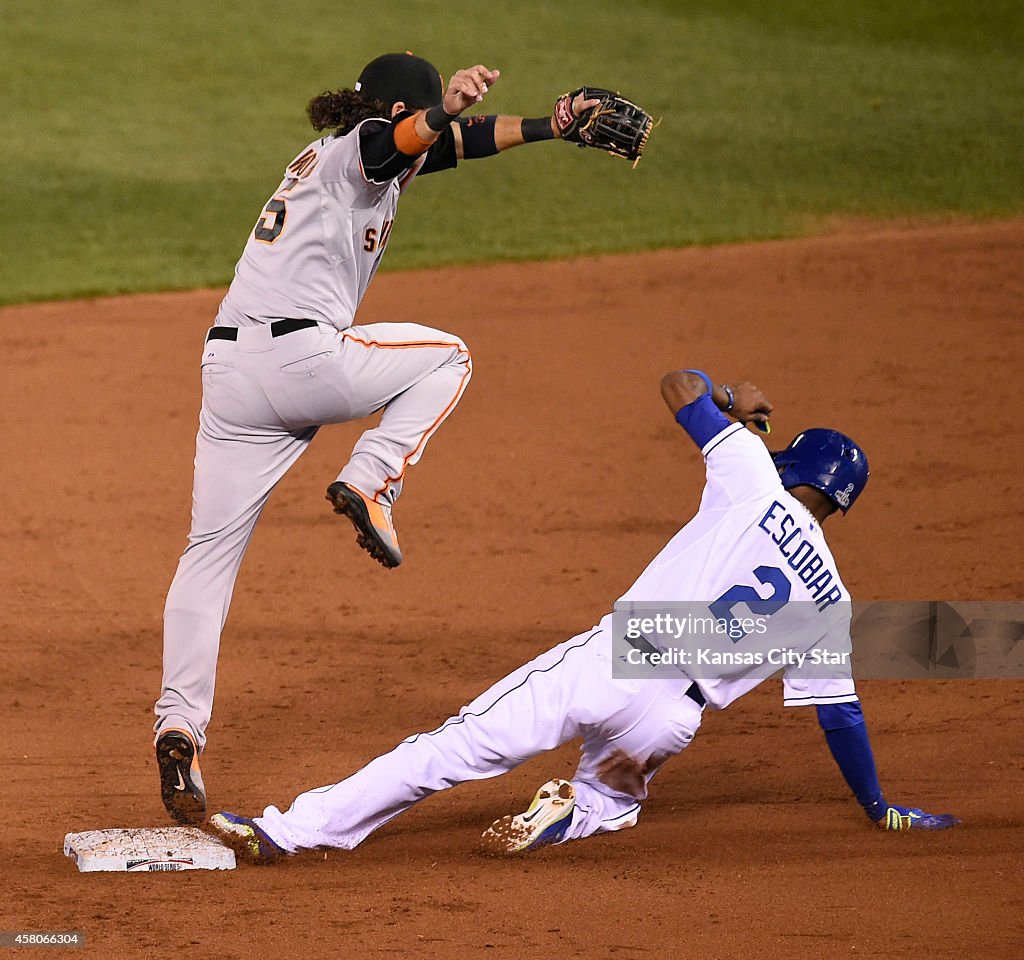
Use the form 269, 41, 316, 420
771, 427, 868, 513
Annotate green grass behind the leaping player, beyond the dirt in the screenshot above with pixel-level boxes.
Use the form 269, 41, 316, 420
0, 0, 1024, 303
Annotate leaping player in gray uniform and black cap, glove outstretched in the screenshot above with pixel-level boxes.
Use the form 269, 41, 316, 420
155, 53, 649, 823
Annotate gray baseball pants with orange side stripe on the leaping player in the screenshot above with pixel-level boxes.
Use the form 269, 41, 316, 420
155, 323, 472, 749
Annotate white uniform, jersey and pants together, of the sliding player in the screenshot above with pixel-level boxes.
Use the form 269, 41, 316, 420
243, 411, 856, 853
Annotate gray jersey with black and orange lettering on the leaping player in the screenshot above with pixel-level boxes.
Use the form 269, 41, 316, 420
217, 119, 424, 330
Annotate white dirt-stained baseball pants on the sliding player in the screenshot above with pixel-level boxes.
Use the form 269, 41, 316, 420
256, 617, 701, 853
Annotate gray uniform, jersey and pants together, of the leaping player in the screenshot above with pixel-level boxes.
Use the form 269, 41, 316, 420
156, 119, 472, 749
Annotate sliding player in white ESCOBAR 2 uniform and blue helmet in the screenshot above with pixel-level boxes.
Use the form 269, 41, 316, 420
210, 370, 959, 861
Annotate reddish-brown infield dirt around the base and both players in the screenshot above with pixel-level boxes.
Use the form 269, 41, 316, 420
0, 221, 1024, 960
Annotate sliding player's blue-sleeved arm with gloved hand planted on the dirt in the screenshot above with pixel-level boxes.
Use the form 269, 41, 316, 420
817, 700, 959, 831
